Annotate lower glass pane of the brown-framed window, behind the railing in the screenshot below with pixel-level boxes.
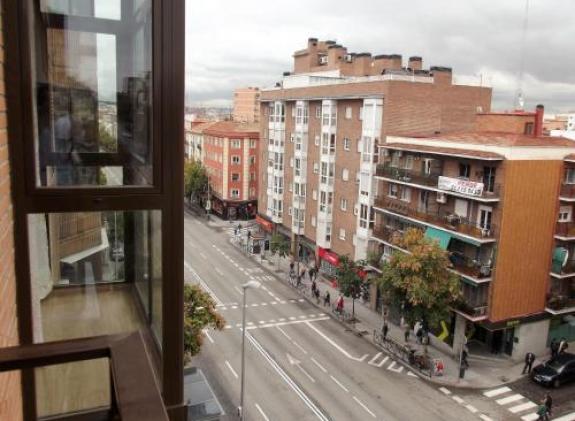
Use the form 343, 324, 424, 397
28, 210, 162, 416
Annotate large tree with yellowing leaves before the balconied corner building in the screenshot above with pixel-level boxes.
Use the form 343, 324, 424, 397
377, 228, 460, 348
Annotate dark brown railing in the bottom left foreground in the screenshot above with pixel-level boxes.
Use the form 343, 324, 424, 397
0, 332, 168, 421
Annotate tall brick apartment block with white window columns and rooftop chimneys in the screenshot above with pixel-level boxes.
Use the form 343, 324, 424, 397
258, 38, 491, 273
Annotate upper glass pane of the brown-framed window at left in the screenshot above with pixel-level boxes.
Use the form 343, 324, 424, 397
29, 0, 154, 187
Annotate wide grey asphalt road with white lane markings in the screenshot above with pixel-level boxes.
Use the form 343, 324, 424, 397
185, 210, 520, 421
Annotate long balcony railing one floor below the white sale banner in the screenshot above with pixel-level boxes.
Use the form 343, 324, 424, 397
375, 198, 496, 239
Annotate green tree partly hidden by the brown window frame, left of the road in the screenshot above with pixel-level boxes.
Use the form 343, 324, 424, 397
184, 284, 226, 360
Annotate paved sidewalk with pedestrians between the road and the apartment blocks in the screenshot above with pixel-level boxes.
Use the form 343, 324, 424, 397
220, 231, 538, 389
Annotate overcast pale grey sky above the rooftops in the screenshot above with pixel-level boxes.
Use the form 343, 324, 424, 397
186, 0, 575, 112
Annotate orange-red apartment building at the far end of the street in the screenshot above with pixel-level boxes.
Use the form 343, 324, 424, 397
201, 121, 260, 219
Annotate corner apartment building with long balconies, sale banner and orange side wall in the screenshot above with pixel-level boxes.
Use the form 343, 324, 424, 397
370, 106, 575, 360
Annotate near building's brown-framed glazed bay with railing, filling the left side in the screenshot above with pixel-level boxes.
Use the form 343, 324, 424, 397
0, 0, 186, 421
